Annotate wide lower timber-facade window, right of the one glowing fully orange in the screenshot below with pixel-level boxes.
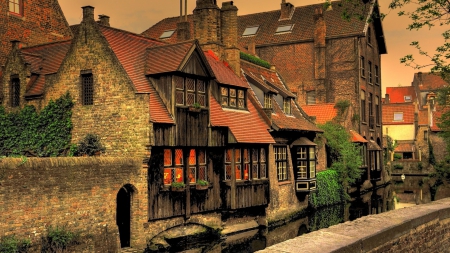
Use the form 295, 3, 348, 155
225, 148, 267, 181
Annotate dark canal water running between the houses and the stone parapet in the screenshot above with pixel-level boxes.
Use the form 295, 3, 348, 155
164, 176, 450, 253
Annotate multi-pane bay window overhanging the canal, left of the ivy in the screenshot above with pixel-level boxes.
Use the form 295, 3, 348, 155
294, 146, 316, 179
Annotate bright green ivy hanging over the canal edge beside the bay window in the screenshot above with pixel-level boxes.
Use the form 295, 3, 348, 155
309, 170, 345, 208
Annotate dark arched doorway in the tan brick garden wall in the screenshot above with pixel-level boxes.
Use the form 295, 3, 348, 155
116, 185, 133, 248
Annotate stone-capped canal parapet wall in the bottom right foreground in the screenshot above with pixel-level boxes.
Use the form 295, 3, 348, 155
260, 198, 450, 253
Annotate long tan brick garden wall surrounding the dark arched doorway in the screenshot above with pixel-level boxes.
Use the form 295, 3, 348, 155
0, 157, 148, 252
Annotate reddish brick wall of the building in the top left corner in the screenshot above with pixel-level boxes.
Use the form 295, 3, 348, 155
0, 0, 72, 66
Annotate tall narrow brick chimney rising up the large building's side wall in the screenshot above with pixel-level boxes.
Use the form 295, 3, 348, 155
314, 7, 327, 79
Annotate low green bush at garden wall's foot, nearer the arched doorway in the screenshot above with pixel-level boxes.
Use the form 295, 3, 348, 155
42, 227, 80, 252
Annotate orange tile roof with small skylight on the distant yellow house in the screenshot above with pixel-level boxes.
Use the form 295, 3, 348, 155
381, 103, 415, 125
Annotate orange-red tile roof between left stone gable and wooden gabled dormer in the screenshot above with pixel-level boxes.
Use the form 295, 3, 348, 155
99, 25, 174, 123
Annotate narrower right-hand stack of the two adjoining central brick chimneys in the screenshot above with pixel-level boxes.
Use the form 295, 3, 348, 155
220, 1, 241, 76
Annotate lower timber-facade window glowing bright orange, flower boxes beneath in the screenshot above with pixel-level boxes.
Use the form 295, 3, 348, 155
164, 149, 208, 185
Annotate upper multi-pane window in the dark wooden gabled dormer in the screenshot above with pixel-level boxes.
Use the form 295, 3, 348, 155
174, 76, 206, 107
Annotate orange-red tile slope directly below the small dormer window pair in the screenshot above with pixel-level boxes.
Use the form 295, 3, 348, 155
210, 96, 275, 143
